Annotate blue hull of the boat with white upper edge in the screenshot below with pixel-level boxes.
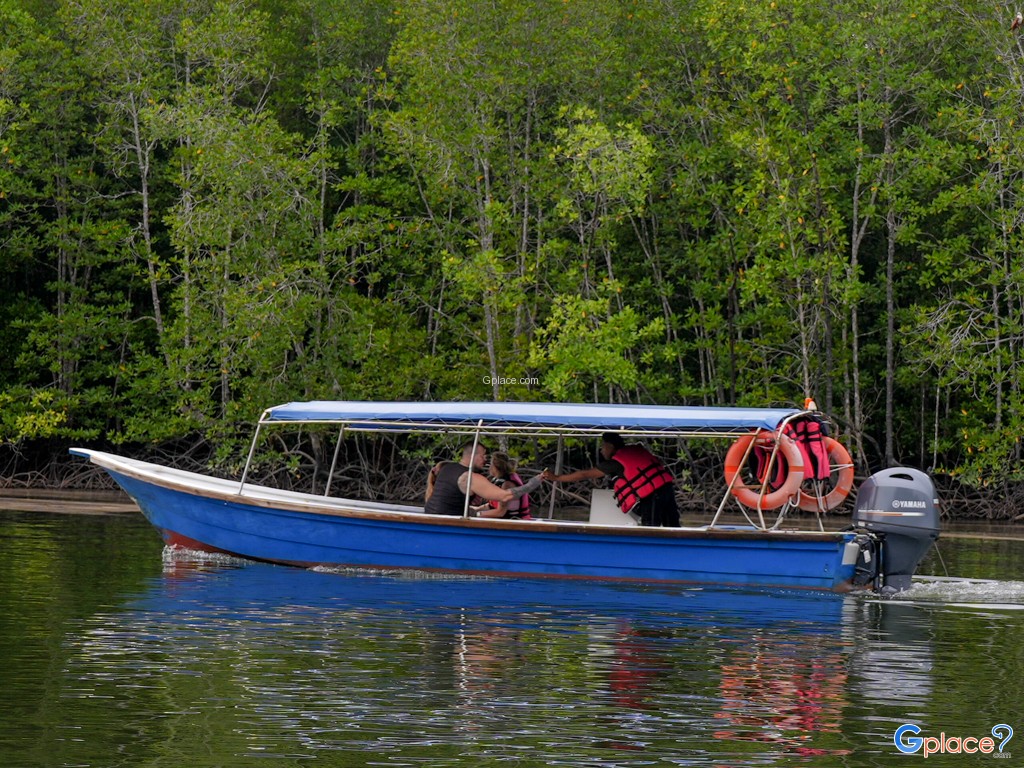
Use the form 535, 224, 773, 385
76, 451, 858, 591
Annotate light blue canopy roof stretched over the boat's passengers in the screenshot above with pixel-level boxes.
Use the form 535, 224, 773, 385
260, 400, 803, 434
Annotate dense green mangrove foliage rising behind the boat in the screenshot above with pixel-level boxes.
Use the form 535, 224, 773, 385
6, 0, 1024, 493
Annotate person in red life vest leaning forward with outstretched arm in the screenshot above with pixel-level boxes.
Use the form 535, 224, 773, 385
542, 432, 679, 528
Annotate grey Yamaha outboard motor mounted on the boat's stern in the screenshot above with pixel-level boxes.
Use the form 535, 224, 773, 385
853, 467, 939, 593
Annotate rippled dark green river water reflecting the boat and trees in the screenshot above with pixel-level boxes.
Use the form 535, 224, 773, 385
0, 512, 1024, 768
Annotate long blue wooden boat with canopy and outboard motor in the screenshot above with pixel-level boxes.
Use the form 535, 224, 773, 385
72, 401, 938, 592
